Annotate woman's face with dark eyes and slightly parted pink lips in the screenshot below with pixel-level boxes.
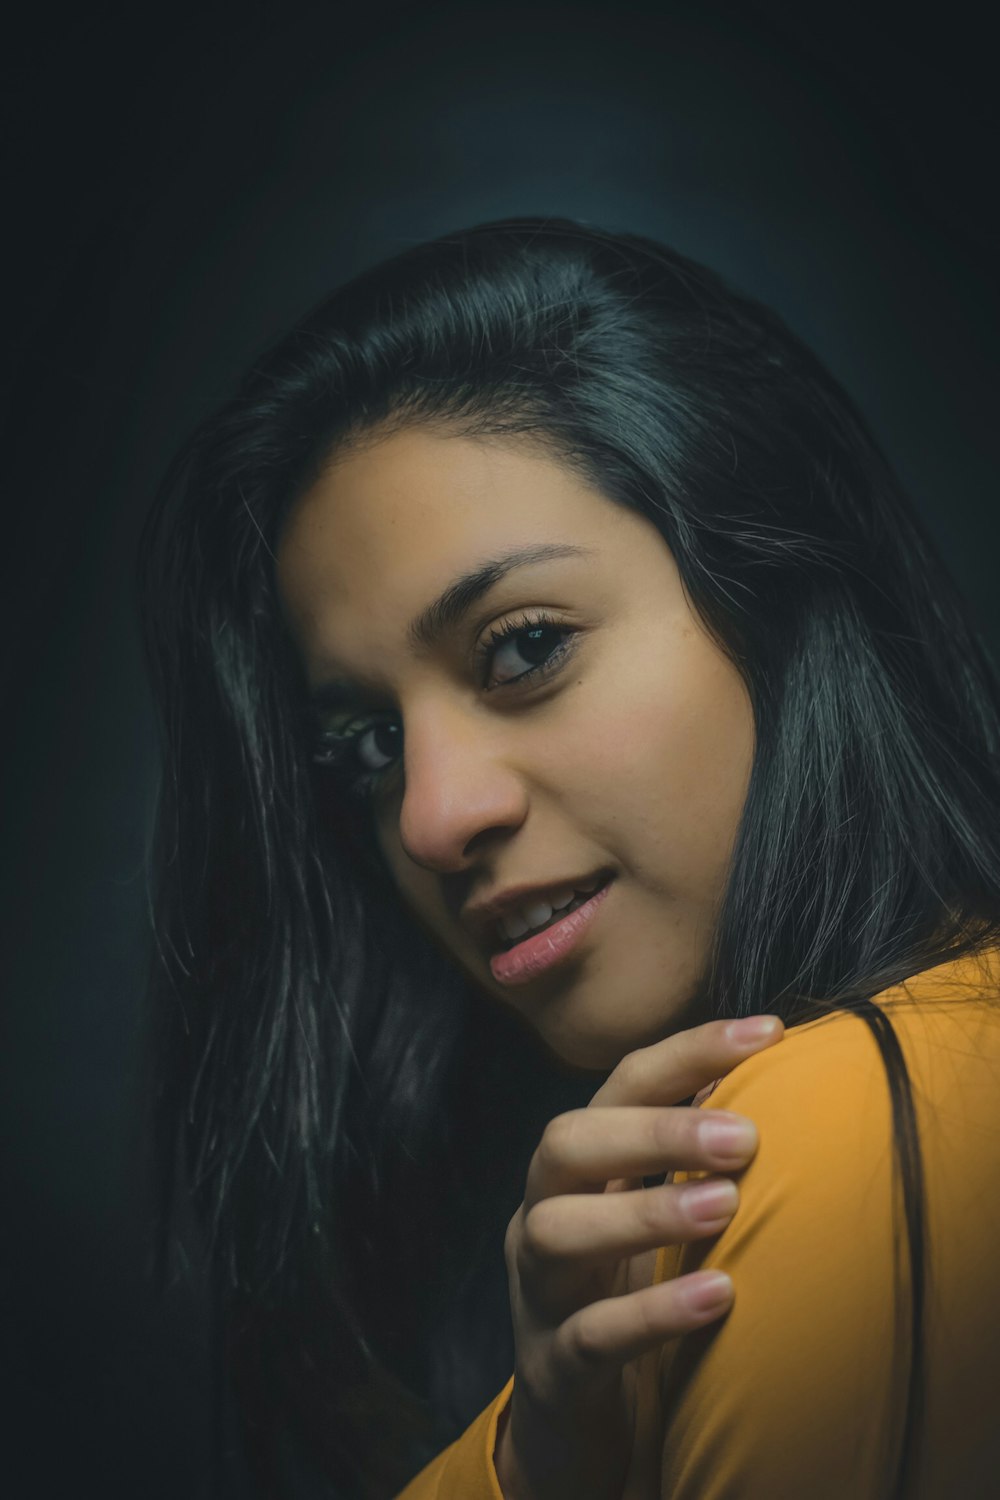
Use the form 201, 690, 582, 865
277, 428, 754, 1070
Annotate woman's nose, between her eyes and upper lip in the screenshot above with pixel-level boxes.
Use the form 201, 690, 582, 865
399, 708, 528, 873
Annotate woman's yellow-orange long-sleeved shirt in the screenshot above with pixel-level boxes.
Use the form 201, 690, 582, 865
397, 950, 1000, 1500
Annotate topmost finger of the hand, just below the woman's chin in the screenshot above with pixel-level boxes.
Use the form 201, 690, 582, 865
591, 1016, 784, 1107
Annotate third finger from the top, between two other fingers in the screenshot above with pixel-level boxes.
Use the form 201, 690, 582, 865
517, 1178, 739, 1283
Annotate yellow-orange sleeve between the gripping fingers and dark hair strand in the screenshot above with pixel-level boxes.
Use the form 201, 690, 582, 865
657, 1013, 910, 1500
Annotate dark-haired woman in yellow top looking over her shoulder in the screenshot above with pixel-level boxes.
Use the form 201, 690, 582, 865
141, 219, 1000, 1500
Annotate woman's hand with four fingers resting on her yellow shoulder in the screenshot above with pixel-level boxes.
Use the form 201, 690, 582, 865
496, 1017, 784, 1500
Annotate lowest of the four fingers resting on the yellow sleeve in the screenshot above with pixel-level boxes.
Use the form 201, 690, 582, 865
552, 1271, 733, 1395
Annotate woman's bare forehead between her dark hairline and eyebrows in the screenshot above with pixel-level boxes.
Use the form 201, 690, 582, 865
277, 428, 625, 669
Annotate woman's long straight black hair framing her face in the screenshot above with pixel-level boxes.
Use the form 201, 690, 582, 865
139, 218, 1000, 1500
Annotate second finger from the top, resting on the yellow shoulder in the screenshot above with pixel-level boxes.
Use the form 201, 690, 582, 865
525, 1104, 757, 1209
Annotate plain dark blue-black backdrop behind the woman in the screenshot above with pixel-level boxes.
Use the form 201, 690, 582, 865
0, 0, 1000, 1500
